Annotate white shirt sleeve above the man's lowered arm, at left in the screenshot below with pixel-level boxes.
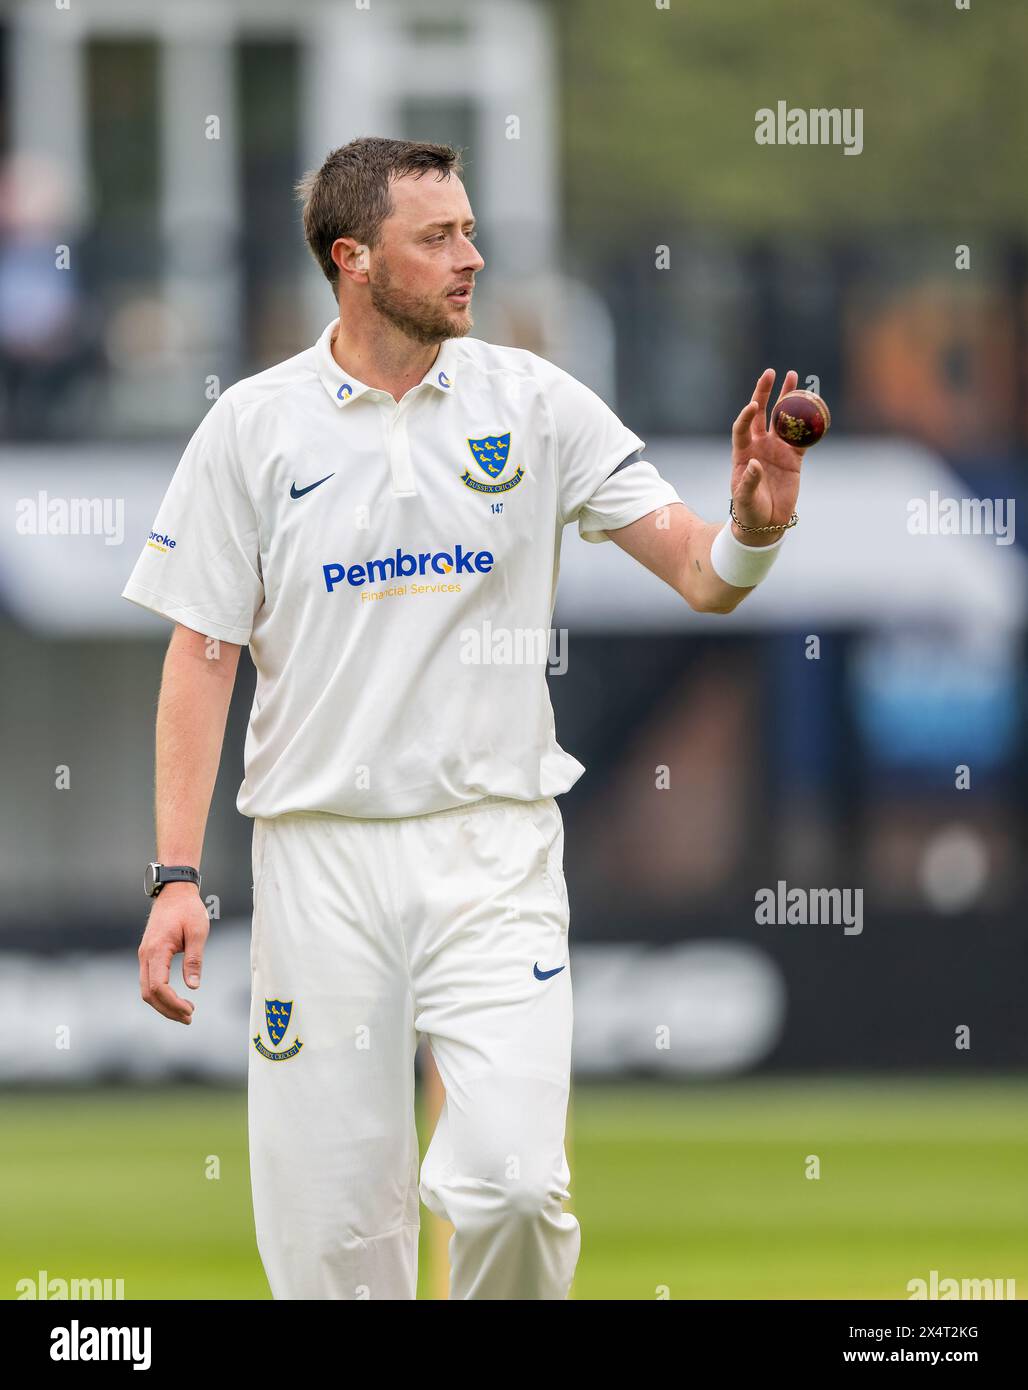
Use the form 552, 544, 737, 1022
121, 389, 264, 646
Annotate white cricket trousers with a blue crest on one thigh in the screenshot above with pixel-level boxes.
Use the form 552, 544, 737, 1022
249, 796, 581, 1298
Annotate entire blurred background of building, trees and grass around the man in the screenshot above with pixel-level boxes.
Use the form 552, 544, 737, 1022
0, 0, 1028, 1298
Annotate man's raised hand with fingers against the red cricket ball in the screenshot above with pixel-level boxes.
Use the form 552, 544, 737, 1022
732, 367, 803, 546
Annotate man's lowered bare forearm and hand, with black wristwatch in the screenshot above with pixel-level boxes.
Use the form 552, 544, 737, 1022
139, 623, 240, 1023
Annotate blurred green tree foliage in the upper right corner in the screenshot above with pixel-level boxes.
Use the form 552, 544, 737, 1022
552, 0, 1028, 261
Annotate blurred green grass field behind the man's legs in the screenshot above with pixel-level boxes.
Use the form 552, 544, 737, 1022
0, 1079, 1028, 1298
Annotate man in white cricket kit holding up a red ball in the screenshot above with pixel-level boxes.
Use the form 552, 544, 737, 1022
124, 139, 802, 1298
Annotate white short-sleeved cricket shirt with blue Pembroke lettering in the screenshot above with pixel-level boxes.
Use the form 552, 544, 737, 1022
122, 320, 681, 817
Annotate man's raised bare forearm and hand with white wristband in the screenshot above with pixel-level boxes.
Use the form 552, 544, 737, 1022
607, 368, 803, 613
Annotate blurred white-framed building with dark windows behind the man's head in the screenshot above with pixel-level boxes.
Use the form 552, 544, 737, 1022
0, 0, 625, 438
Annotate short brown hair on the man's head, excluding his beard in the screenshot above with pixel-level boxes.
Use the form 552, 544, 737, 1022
296, 135, 464, 299
